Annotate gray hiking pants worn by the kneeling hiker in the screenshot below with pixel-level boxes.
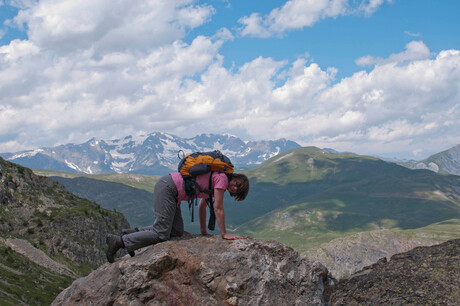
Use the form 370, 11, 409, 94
122, 175, 184, 252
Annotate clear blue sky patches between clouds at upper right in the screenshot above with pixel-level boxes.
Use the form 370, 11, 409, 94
197, 0, 460, 79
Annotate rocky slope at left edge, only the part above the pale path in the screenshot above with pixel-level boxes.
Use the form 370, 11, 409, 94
0, 158, 129, 266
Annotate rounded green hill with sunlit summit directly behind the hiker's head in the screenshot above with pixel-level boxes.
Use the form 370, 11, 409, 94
225, 147, 411, 226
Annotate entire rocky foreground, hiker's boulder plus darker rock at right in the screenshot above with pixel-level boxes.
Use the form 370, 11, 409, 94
52, 235, 460, 305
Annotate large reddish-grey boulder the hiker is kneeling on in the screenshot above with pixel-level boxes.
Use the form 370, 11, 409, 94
52, 235, 328, 305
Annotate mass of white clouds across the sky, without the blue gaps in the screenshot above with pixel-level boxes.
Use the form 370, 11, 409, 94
0, 0, 460, 159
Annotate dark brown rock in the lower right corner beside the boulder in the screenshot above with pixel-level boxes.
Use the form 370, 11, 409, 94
325, 239, 460, 305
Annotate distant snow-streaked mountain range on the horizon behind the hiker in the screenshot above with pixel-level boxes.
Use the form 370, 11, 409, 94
0, 132, 300, 175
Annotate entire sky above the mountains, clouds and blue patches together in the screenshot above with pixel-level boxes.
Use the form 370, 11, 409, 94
0, 0, 460, 159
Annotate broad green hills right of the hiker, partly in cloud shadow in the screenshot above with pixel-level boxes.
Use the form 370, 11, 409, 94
236, 147, 460, 252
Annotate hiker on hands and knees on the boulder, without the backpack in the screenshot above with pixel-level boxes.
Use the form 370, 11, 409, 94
106, 172, 249, 263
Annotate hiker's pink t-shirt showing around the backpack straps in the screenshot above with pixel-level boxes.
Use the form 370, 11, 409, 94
170, 172, 228, 205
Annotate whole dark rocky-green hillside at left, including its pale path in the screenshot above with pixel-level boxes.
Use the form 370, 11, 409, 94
0, 158, 128, 305
